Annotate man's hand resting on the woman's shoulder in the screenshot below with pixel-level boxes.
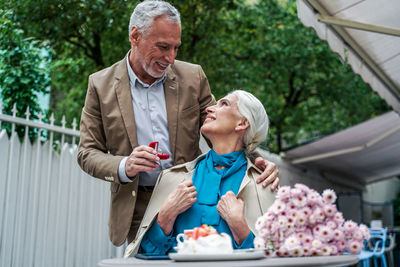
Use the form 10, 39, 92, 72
254, 157, 279, 191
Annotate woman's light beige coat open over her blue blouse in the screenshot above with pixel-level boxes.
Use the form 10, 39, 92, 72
124, 155, 275, 257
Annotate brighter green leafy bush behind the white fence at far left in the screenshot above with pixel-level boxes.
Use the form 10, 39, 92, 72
0, 10, 50, 138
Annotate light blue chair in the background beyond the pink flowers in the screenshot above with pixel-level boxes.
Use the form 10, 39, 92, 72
358, 228, 387, 267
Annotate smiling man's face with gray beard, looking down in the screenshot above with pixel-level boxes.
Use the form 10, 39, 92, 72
129, 17, 181, 84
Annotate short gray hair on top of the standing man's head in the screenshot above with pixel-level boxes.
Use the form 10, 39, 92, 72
128, 0, 181, 34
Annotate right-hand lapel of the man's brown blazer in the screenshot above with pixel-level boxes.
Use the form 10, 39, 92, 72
164, 66, 179, 161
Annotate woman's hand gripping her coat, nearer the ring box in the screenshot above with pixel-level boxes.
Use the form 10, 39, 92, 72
157, 181, 197, 235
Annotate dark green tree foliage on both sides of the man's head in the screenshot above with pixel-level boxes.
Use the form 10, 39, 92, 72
5, 0, 389, 152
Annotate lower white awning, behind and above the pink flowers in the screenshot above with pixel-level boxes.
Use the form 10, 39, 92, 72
283, 111, 400, 184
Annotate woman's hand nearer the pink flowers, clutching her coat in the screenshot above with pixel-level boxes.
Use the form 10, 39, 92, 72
217, 191, 250, 246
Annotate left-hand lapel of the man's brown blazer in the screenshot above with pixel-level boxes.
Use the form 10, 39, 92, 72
114, 54, 137, 149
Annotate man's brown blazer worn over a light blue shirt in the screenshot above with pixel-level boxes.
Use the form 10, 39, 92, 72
78, 54, 215, 246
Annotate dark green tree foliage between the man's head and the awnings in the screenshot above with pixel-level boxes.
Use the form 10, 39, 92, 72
174, 1, 389, 152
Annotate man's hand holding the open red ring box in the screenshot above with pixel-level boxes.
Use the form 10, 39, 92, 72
125, 146, 160, 177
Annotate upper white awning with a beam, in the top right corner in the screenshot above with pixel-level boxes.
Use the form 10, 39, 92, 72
297, 0, 400, 114
